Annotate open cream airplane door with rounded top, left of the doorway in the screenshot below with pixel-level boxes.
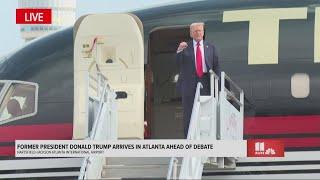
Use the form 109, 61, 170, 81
73, 14, 144, 139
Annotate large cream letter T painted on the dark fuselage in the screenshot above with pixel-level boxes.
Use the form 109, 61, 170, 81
223, 7, 308, 64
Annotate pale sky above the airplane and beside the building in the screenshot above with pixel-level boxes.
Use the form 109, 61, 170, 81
0, 0, 177, 57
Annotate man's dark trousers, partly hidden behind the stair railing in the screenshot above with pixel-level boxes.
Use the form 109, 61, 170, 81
182, 73, 210, 138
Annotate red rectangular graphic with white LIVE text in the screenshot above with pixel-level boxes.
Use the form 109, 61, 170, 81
16, 9, 52, 24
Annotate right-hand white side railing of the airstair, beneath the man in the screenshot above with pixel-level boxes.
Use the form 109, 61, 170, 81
167, 70, 244, 179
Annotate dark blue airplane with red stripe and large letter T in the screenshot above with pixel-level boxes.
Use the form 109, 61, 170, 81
0, 0, 320, 178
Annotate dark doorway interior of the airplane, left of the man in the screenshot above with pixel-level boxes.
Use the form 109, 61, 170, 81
146, 26, 191, 139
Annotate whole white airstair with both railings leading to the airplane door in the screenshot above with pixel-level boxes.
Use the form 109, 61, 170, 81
79, 71, 244, 179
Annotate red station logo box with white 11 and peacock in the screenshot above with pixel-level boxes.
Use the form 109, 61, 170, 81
247, 139, 284, 157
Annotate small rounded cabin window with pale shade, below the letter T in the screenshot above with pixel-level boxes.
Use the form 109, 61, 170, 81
291, 73, 310, 98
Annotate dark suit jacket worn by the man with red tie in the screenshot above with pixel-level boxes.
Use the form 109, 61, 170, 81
176, 41, 220, 96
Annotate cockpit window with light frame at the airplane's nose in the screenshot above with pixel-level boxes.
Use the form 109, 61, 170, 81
0, 83, 37, 123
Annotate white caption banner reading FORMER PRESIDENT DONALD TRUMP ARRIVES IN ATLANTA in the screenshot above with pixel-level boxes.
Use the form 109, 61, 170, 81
15, 140, 247, 157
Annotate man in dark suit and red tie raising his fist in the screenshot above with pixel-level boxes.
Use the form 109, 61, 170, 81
176, 23, 220, 137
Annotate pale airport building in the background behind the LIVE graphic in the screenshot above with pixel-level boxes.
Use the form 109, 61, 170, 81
18, 0, 76, 41
